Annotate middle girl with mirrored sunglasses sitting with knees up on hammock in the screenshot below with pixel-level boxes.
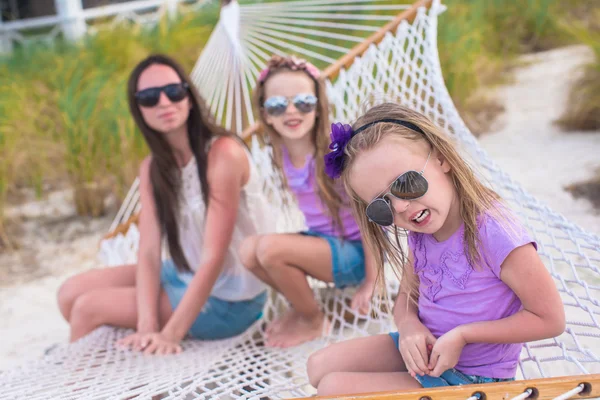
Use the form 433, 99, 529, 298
242, 56, 376, 347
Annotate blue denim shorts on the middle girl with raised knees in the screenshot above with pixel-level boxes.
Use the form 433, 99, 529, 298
302, 231, 365, 289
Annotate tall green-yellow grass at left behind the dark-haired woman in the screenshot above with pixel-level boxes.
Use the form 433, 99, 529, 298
0, 6, 218, 216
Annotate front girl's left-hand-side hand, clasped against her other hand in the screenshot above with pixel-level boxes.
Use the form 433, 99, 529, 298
398, 318, 436, 378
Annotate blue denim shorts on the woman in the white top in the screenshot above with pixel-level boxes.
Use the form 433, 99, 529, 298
160, 260, 267, 340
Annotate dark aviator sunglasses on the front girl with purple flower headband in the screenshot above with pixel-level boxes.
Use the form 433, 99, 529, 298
366, 151, 431, 226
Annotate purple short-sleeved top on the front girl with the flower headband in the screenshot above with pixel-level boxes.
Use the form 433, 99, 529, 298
408, 209, 537, 378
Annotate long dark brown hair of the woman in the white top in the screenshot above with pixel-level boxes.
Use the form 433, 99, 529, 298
127, 54, 232, 271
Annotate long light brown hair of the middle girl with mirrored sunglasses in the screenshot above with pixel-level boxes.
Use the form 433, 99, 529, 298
252, 55, 348, 236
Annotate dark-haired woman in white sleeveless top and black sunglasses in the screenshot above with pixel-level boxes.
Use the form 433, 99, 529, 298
58, 55, 274, 354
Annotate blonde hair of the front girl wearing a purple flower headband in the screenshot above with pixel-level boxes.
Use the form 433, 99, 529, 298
341, 103, 502, 296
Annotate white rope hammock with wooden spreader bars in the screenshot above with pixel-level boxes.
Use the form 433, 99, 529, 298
0, 0, 600, 400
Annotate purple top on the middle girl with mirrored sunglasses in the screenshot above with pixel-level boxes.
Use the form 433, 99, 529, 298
282, 146, 360, 240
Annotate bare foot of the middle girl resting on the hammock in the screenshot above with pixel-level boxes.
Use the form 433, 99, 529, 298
266, 310, 330, 347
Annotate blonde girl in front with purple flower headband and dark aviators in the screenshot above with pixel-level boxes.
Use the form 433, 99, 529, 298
308, 103, 565, 395
